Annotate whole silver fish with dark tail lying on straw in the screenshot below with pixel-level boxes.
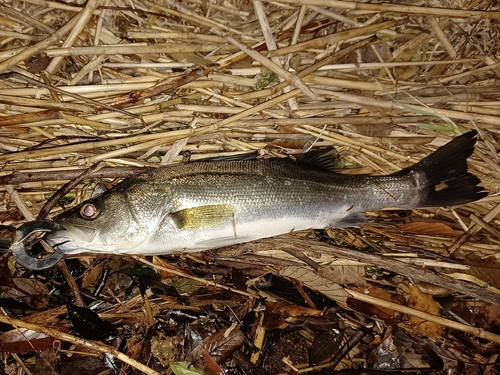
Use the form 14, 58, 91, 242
45, 131, 488, 255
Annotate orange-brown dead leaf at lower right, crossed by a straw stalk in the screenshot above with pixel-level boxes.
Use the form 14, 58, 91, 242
408, 285, 444, 336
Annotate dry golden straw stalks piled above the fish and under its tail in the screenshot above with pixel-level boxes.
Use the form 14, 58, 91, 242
0, 0, 500, 374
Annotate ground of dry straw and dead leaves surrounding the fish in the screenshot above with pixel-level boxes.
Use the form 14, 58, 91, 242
0, 0, 500, 374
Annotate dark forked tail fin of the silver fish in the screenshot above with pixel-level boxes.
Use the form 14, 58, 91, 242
397, 130, 488, 207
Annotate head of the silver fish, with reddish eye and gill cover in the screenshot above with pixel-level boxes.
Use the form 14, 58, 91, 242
45, 191, 147, 254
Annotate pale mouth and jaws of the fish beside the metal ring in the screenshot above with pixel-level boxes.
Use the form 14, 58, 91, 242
44, 221, 98, 253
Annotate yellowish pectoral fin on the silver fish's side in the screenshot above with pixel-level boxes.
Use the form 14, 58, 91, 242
170, 204, 236, 232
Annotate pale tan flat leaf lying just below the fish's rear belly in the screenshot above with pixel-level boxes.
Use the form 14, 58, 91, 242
279, 266, 349, 303
